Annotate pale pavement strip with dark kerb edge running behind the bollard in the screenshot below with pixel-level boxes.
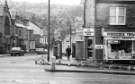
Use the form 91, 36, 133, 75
45, 65, 135, 75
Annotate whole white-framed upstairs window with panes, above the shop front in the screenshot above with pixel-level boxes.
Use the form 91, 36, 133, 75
110, 7, 126, 25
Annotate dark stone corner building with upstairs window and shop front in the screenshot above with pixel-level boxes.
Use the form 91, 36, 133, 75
86, 0, 135, 64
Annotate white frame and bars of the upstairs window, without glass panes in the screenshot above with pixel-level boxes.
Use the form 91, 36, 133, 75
109, 7, 126, 25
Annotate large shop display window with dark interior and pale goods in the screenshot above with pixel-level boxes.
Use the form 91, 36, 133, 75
107, 40, 135, 59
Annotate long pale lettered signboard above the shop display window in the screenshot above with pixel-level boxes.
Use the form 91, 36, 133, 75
103, 32, 135, 37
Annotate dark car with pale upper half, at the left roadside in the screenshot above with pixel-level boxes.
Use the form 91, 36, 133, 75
10, 47, 25, 56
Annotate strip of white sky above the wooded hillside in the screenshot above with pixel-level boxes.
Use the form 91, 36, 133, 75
13, 0, 81, 5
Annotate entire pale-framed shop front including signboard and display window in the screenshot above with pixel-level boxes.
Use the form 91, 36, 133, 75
103, 32, 135, 60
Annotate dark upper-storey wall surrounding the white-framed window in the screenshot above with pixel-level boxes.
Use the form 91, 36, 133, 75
96, 2, 135, 28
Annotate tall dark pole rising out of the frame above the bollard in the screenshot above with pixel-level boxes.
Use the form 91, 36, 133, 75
47, 0, 50, 62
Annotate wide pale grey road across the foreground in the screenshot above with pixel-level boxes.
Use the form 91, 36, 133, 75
0, 55, 135, 84
